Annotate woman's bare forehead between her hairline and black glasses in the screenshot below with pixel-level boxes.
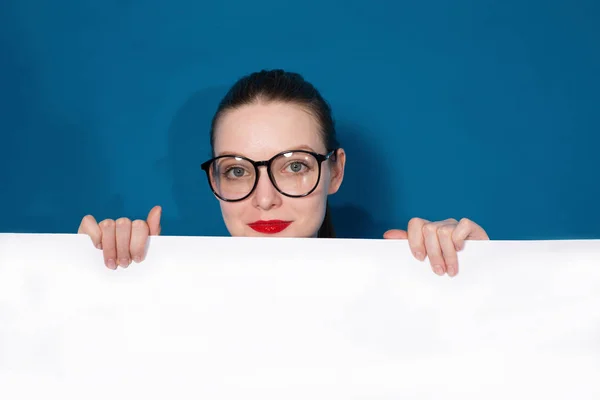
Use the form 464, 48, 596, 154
214, 102, 326, 160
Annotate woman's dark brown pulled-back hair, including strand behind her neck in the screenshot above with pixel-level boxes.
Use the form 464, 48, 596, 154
210, 69, 339, 238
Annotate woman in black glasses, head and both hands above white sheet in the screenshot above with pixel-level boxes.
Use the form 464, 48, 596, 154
78, 70, 489, 276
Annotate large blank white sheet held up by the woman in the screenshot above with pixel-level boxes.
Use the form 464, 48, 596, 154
0, 234, 600, 400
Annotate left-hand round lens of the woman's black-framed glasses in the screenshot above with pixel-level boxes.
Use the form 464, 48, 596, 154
209, 156, 256, 200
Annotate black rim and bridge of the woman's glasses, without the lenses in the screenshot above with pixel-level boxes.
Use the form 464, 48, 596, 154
201, 149, 338, 203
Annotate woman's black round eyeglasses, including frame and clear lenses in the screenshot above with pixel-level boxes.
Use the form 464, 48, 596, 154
202, 149, 337, 202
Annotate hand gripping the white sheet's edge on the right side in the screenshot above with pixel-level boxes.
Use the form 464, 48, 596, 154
383, 218, 489, 276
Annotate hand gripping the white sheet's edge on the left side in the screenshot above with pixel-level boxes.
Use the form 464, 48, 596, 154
77, 206, 162, 269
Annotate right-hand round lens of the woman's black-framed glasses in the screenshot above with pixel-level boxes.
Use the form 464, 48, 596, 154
271, 152, 319, 196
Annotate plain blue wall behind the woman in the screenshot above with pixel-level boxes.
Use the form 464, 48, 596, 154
0, 0, 600, 239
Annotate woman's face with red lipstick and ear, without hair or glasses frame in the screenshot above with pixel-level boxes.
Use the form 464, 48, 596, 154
214, 102, 345, 237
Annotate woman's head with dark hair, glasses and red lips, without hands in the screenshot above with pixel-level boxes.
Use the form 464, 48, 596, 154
203, 70, 345, 237
